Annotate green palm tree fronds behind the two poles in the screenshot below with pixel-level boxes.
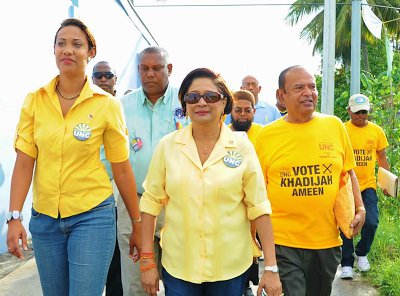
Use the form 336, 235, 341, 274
286, 0, 400, 72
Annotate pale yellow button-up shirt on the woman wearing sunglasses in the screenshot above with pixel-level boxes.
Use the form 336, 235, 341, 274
140, 124, 271, 283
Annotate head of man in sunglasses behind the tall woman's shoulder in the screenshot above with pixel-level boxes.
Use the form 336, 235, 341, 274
92, 61, 117, 96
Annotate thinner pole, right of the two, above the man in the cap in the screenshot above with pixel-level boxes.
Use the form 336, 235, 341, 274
350, 0, 361, 95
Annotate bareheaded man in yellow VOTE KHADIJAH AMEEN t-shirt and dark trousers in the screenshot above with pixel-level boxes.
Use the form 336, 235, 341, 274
256, 66, 365, 296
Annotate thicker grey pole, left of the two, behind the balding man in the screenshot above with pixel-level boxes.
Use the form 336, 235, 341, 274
321, 0, 336, 115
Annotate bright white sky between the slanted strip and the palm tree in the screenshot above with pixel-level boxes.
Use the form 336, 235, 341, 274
135, 0, 321, 102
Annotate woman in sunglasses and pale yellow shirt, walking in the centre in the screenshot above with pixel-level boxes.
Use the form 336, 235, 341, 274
140, 68, 281, 296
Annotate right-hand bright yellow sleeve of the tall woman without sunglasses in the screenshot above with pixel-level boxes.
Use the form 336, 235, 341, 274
103, 99, 129, 162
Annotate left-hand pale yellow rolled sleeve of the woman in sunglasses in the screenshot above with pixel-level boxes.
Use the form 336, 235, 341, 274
140, 140, 167, 216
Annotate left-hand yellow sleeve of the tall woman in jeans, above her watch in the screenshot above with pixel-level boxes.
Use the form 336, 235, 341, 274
14, 94, 38, 159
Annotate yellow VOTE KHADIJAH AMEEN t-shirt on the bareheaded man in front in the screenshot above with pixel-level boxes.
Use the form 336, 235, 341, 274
256, 113, 355, 249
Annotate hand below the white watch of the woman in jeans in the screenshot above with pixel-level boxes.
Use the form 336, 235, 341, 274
7, 220, 28, 259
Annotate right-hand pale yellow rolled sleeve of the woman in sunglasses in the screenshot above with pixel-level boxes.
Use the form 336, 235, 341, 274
243, 146, 272, 220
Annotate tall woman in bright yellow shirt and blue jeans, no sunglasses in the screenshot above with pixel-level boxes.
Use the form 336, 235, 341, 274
7, 19, 141, 296
